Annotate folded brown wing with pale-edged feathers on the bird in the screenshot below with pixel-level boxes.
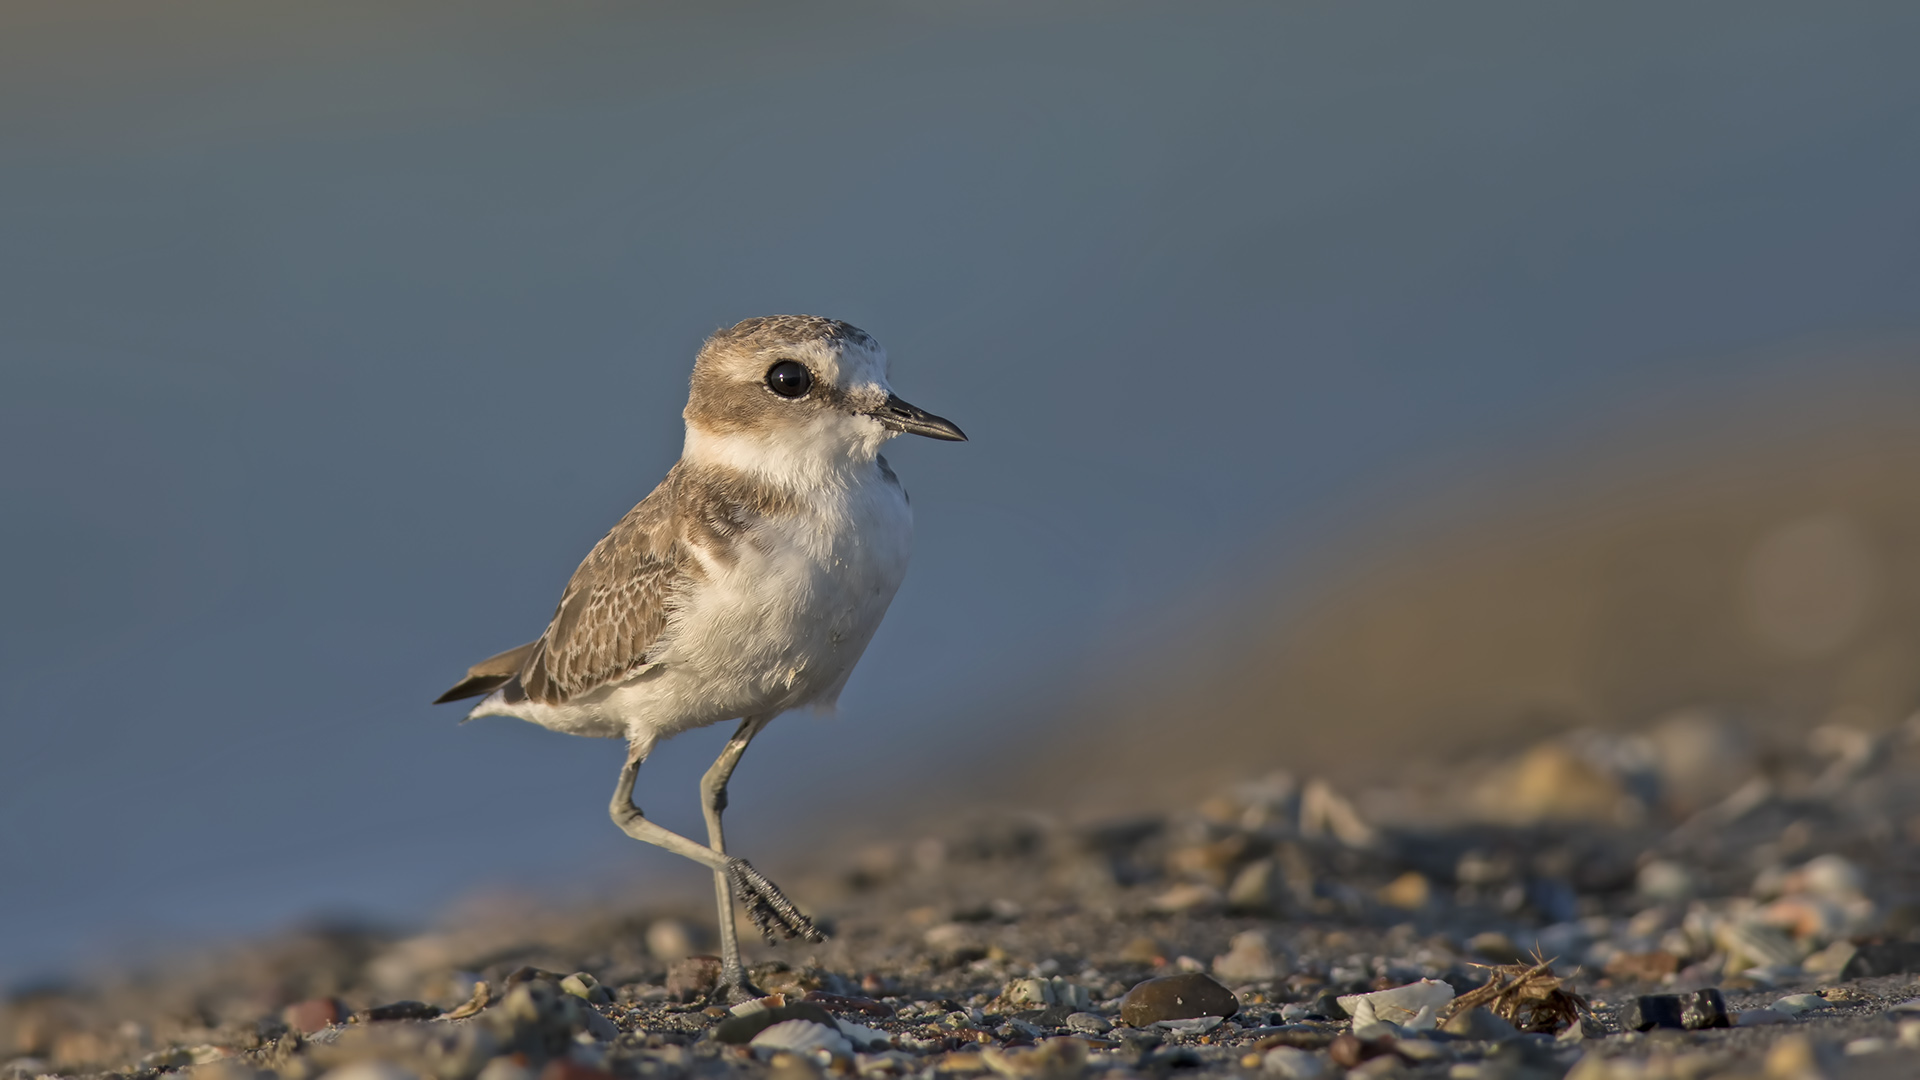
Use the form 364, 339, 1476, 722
505, 477, 685, 705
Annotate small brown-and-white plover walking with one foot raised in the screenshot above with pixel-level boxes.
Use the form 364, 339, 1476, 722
434, 315, 966, 1003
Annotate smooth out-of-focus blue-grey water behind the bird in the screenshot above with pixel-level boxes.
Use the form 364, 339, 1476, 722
0, 0, 1920, 978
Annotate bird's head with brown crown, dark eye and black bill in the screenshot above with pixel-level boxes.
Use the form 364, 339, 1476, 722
684, 315, 966, 479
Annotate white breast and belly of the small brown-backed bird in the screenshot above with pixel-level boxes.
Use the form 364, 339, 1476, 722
491, 469, 914, 744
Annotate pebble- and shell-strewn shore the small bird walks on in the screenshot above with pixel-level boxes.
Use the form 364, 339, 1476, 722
11, 713, 1920, 1080
